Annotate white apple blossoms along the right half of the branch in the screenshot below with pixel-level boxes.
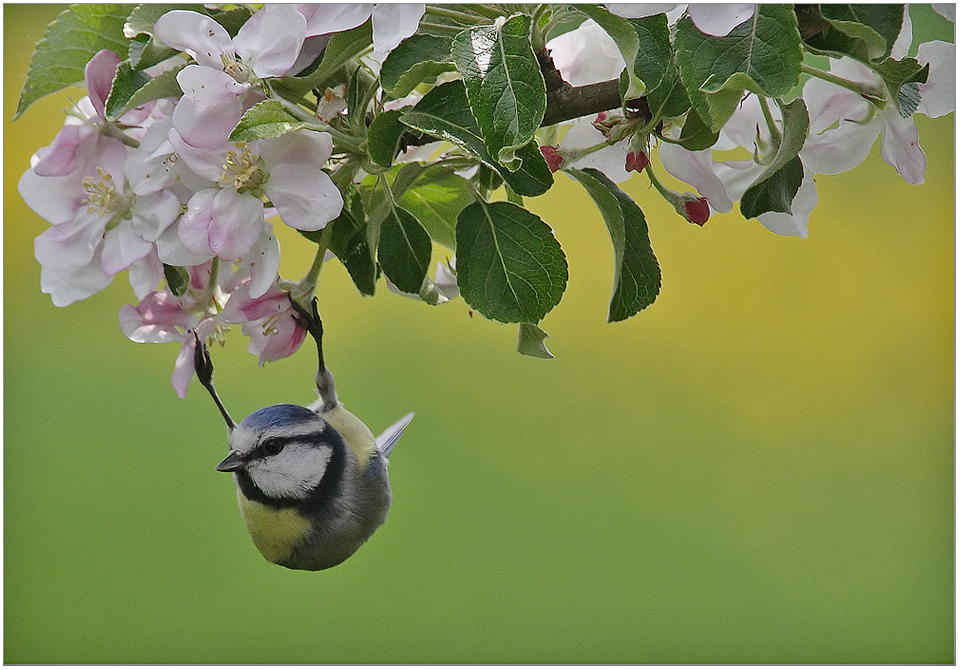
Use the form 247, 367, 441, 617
548, 4, 956, 237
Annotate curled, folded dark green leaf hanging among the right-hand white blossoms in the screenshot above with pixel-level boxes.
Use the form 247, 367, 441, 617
740, 98, 810, 219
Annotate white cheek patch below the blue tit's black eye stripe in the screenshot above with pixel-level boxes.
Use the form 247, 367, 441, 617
247, 444, 332, 499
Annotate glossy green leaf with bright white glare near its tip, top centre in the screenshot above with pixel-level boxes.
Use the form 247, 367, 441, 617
451, 15, 547, 170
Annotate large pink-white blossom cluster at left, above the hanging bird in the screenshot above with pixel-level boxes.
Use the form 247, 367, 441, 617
19, 4, 424, 397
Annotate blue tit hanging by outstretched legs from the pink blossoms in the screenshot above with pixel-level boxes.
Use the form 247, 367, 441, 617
194, 296, 413, 570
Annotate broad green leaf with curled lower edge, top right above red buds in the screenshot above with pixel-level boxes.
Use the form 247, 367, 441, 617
674, 5, 803, 131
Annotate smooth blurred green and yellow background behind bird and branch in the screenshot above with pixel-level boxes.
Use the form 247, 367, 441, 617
3, 5, 955, 663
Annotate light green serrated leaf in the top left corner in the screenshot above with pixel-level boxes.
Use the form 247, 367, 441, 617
13, 5, 133, 119
